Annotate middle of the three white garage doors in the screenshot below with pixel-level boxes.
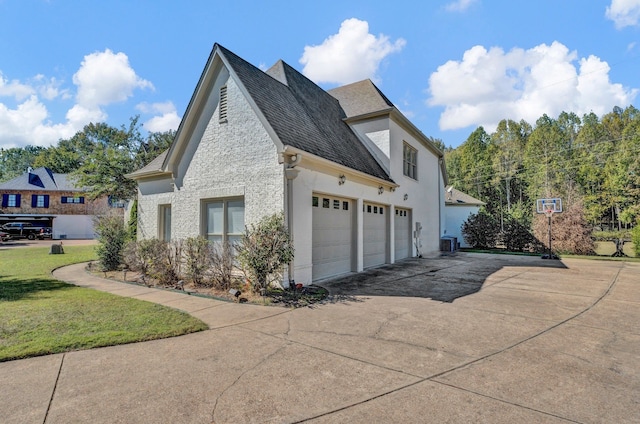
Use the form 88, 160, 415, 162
362, 203, 388, 268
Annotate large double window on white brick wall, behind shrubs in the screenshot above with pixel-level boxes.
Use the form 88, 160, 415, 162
203, 199, 244, 243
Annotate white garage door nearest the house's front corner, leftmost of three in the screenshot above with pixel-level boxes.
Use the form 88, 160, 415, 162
311, 195, 353, 280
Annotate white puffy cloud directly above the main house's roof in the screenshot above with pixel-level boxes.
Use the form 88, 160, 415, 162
300, 18, 406, 84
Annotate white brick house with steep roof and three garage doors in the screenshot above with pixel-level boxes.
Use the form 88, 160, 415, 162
128, 44, 446, 285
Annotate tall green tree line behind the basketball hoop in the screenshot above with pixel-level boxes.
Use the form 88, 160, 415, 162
444, 106, 640, 234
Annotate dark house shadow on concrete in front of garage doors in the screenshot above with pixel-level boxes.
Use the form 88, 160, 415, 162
317, 252, 566, 302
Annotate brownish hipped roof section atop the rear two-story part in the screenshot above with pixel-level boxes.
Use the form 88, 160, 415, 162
328, 79, 394, 117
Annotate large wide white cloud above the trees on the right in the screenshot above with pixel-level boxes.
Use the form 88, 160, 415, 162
427, 42, 638, 131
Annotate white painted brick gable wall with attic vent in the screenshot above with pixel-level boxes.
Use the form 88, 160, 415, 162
138, 79, 284, 239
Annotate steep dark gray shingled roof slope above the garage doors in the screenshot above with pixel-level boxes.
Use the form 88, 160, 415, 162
214, 44, 393, 181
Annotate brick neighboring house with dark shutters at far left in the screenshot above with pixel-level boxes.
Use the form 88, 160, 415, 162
0, 167, 108, 239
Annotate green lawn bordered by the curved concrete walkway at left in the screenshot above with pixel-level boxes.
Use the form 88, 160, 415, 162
0, 246, 207, 361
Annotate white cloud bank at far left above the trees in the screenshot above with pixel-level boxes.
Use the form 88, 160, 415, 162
0, 49, 154, 148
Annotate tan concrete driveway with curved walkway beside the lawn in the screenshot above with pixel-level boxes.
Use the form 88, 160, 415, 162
0, 254, 640, 423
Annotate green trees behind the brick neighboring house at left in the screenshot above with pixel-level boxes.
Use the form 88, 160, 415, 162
0, 116, 175, 199
